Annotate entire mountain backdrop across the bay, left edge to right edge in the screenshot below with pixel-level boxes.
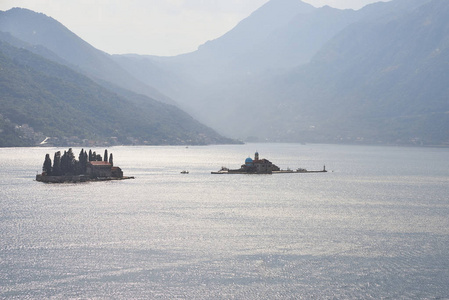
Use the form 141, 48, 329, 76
0, 0, 449, 146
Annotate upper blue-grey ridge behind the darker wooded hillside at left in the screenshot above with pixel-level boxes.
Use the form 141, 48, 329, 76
0, 8, 173, 103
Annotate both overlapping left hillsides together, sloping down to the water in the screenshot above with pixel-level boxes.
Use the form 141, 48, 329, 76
0, 9, 235, 147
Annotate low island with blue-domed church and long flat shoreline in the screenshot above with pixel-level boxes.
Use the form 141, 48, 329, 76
211, 152, 327, 174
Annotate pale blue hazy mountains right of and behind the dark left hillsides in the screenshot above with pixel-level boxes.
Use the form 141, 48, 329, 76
113, 0, 449, 145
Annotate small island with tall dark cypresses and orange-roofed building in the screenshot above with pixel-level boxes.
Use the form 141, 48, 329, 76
36, 148, 134, 183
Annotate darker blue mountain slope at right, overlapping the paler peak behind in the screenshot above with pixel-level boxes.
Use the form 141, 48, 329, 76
242, 1, 449, 144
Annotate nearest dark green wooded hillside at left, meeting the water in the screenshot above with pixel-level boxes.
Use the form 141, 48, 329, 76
0, 42, 236, 146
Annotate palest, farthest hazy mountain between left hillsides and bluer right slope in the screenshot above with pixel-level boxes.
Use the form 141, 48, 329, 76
142, 0, 360, 126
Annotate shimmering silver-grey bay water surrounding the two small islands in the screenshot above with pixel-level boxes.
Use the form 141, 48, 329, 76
0, 144, 449, 299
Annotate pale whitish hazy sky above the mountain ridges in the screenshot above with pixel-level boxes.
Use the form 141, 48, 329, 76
0, 0, 386, 56
